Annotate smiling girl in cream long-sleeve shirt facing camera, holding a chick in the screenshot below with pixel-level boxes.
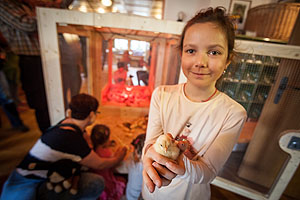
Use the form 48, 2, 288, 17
142, 7, 246, 200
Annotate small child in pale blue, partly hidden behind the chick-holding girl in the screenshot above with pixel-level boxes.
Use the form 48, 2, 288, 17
116, 134, 146, 200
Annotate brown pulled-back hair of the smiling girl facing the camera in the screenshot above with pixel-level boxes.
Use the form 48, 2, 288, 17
179, 6, 235, 60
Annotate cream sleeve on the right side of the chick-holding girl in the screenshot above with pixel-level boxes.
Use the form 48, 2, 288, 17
178, 110, 246, 184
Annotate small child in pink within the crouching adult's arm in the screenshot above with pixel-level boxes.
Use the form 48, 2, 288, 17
91, 124, 125, 200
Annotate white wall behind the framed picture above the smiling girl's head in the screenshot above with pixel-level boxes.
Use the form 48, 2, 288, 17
164, 0, 277, 22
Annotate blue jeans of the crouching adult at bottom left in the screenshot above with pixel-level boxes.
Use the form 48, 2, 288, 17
1, 171, 104, 200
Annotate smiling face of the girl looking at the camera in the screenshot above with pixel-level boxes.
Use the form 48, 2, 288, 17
181, 22, 230, 88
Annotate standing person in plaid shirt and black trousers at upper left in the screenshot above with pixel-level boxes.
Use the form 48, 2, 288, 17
0, 0, 50, 132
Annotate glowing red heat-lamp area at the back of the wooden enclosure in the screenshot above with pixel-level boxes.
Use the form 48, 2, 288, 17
101, 40, 156, 107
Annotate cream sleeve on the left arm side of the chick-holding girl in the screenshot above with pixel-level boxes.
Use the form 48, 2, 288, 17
143, 87, 163, 155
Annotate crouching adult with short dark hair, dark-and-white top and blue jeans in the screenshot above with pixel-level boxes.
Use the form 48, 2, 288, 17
0, 94, 126, 200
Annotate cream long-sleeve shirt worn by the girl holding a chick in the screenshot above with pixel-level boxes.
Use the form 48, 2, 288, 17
142, 84, 247, 200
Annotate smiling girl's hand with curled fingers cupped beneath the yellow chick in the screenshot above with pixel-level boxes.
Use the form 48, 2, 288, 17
143, 146, 185, 193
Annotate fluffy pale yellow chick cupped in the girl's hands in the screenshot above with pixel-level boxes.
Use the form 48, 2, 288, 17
153, 133, 180, 160
